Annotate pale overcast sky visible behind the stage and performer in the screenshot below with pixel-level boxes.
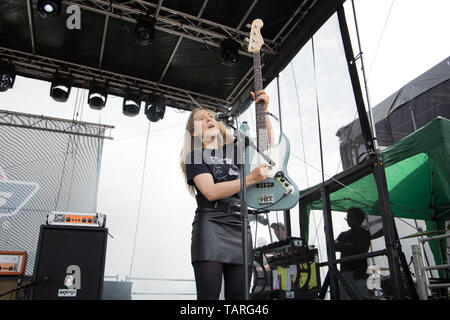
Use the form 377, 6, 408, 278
0, 0, 450, 299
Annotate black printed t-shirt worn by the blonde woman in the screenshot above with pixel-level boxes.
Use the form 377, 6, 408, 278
186, 143, 239, 202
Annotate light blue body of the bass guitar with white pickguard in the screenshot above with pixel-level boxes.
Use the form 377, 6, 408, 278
241, 123, 300, 211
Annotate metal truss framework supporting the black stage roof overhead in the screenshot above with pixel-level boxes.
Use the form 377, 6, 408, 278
15, 0, 318, 111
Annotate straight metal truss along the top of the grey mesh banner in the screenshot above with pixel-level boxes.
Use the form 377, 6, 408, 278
0, 110, 114, 140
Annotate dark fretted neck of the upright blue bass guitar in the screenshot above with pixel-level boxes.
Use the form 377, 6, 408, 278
253, 51, 269, 151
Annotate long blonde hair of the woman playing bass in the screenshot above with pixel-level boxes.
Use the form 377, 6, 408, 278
180, 108, 234, 196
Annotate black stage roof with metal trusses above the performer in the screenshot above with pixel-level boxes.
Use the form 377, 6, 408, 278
0, 0, 345, 112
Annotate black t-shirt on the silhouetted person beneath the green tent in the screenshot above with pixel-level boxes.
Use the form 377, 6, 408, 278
336, 227, 370, 278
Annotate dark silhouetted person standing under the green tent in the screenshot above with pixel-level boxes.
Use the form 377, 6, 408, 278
336, 207, 370, 300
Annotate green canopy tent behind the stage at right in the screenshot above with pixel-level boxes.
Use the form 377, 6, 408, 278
300, 117, 450, 276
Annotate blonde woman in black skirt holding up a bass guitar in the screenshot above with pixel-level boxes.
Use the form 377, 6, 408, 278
181, 90, 272, 300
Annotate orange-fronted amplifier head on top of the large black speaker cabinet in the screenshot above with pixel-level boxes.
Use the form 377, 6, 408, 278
47, 212, 106, 228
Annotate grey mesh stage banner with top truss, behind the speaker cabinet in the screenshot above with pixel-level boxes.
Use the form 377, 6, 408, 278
0, 110, 110, 275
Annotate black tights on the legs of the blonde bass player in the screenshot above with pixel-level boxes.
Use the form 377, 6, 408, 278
192, 261, 252, 300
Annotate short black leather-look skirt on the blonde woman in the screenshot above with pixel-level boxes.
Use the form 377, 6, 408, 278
191, 207, 253, 265
